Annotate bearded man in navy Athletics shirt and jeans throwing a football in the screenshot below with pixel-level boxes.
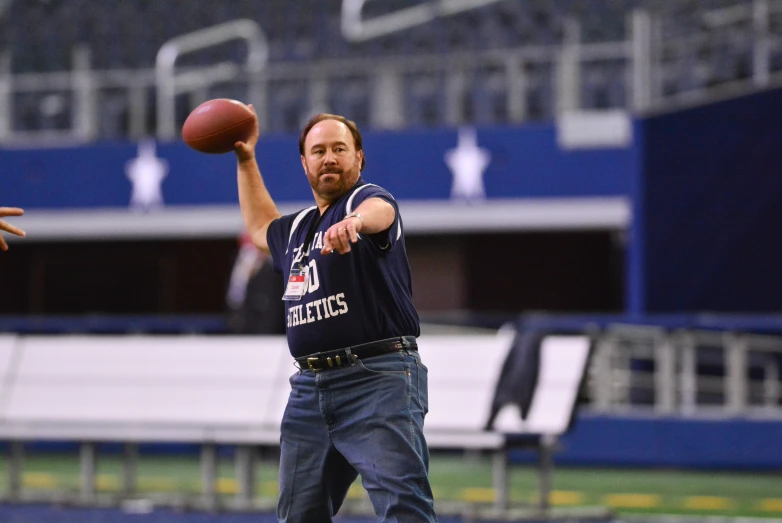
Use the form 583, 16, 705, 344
235, 108, 437, 523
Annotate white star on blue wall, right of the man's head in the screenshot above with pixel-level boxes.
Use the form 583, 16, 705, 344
445, 128, 491, 201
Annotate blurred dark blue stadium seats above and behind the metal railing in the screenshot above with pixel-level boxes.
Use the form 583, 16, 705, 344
0, 0, 780, 135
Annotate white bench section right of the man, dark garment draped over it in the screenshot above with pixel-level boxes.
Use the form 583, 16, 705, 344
422, 330, 590, 510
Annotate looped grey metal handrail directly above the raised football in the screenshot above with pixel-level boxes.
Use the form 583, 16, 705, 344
155, 18, 269, 140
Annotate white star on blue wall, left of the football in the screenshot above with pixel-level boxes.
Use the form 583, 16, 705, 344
125, 140, 168, 212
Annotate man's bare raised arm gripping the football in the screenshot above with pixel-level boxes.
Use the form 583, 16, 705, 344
234, 106, 280, 252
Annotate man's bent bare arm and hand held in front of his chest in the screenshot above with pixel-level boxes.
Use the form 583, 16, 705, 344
320, 198, 396, 254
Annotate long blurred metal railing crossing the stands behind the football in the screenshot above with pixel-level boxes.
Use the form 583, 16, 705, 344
0, 0, 782, 147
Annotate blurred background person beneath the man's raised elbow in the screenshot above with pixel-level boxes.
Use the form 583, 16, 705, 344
225, 233, 285, 334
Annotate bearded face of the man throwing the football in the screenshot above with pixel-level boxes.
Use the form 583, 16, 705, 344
301, 120, 363, 202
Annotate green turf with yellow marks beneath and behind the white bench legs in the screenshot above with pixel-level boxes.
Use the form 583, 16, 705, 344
0, 454, 782, 518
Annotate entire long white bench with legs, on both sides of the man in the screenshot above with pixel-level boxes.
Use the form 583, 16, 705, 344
0, 329, 589, 507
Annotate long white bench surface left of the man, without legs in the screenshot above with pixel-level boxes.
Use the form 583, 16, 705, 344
2, 336, 292, 444
